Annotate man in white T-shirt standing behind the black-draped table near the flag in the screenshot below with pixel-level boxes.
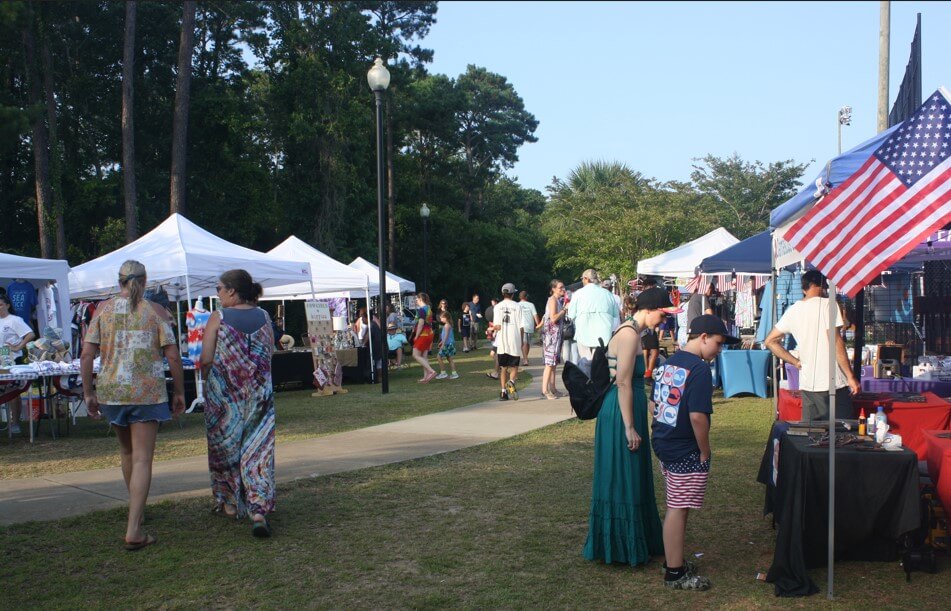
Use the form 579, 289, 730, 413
765, 270, 861, 420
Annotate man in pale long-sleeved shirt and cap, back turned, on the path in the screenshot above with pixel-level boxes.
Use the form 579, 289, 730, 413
568, 269, 621, 375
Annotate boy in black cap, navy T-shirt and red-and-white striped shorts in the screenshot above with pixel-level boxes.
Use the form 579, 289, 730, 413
651, 314, 740, 590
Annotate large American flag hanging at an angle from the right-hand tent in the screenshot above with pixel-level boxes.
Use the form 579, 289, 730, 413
779, 88, 951, 297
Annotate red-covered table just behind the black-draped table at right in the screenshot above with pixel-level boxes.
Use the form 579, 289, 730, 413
778, 390, 951, 460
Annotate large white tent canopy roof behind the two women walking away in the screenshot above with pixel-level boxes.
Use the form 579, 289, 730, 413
69, 214, 311, 300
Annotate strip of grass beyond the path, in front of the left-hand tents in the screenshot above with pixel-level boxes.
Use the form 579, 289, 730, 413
0, 350, 532, 479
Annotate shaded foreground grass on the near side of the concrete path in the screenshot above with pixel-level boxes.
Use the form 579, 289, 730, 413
0, 399, 951, 609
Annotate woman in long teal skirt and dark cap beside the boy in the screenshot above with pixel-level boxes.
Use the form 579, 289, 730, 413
584, 298, 666, 566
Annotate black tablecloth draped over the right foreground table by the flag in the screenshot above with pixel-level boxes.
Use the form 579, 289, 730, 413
757, 423, 921, 596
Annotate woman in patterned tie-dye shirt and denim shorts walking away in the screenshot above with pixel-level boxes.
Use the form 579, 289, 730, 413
80, 261, 185, 551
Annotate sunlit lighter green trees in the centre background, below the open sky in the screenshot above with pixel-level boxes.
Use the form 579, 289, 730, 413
542, 154, 806, 278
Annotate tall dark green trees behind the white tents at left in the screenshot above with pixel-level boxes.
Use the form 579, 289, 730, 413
0, 0, 551, 301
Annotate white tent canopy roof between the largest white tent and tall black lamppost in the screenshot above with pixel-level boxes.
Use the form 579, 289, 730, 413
263, 236, 379, 299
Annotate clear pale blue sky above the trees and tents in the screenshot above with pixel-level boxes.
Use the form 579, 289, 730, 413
422, 1, 951, 192
